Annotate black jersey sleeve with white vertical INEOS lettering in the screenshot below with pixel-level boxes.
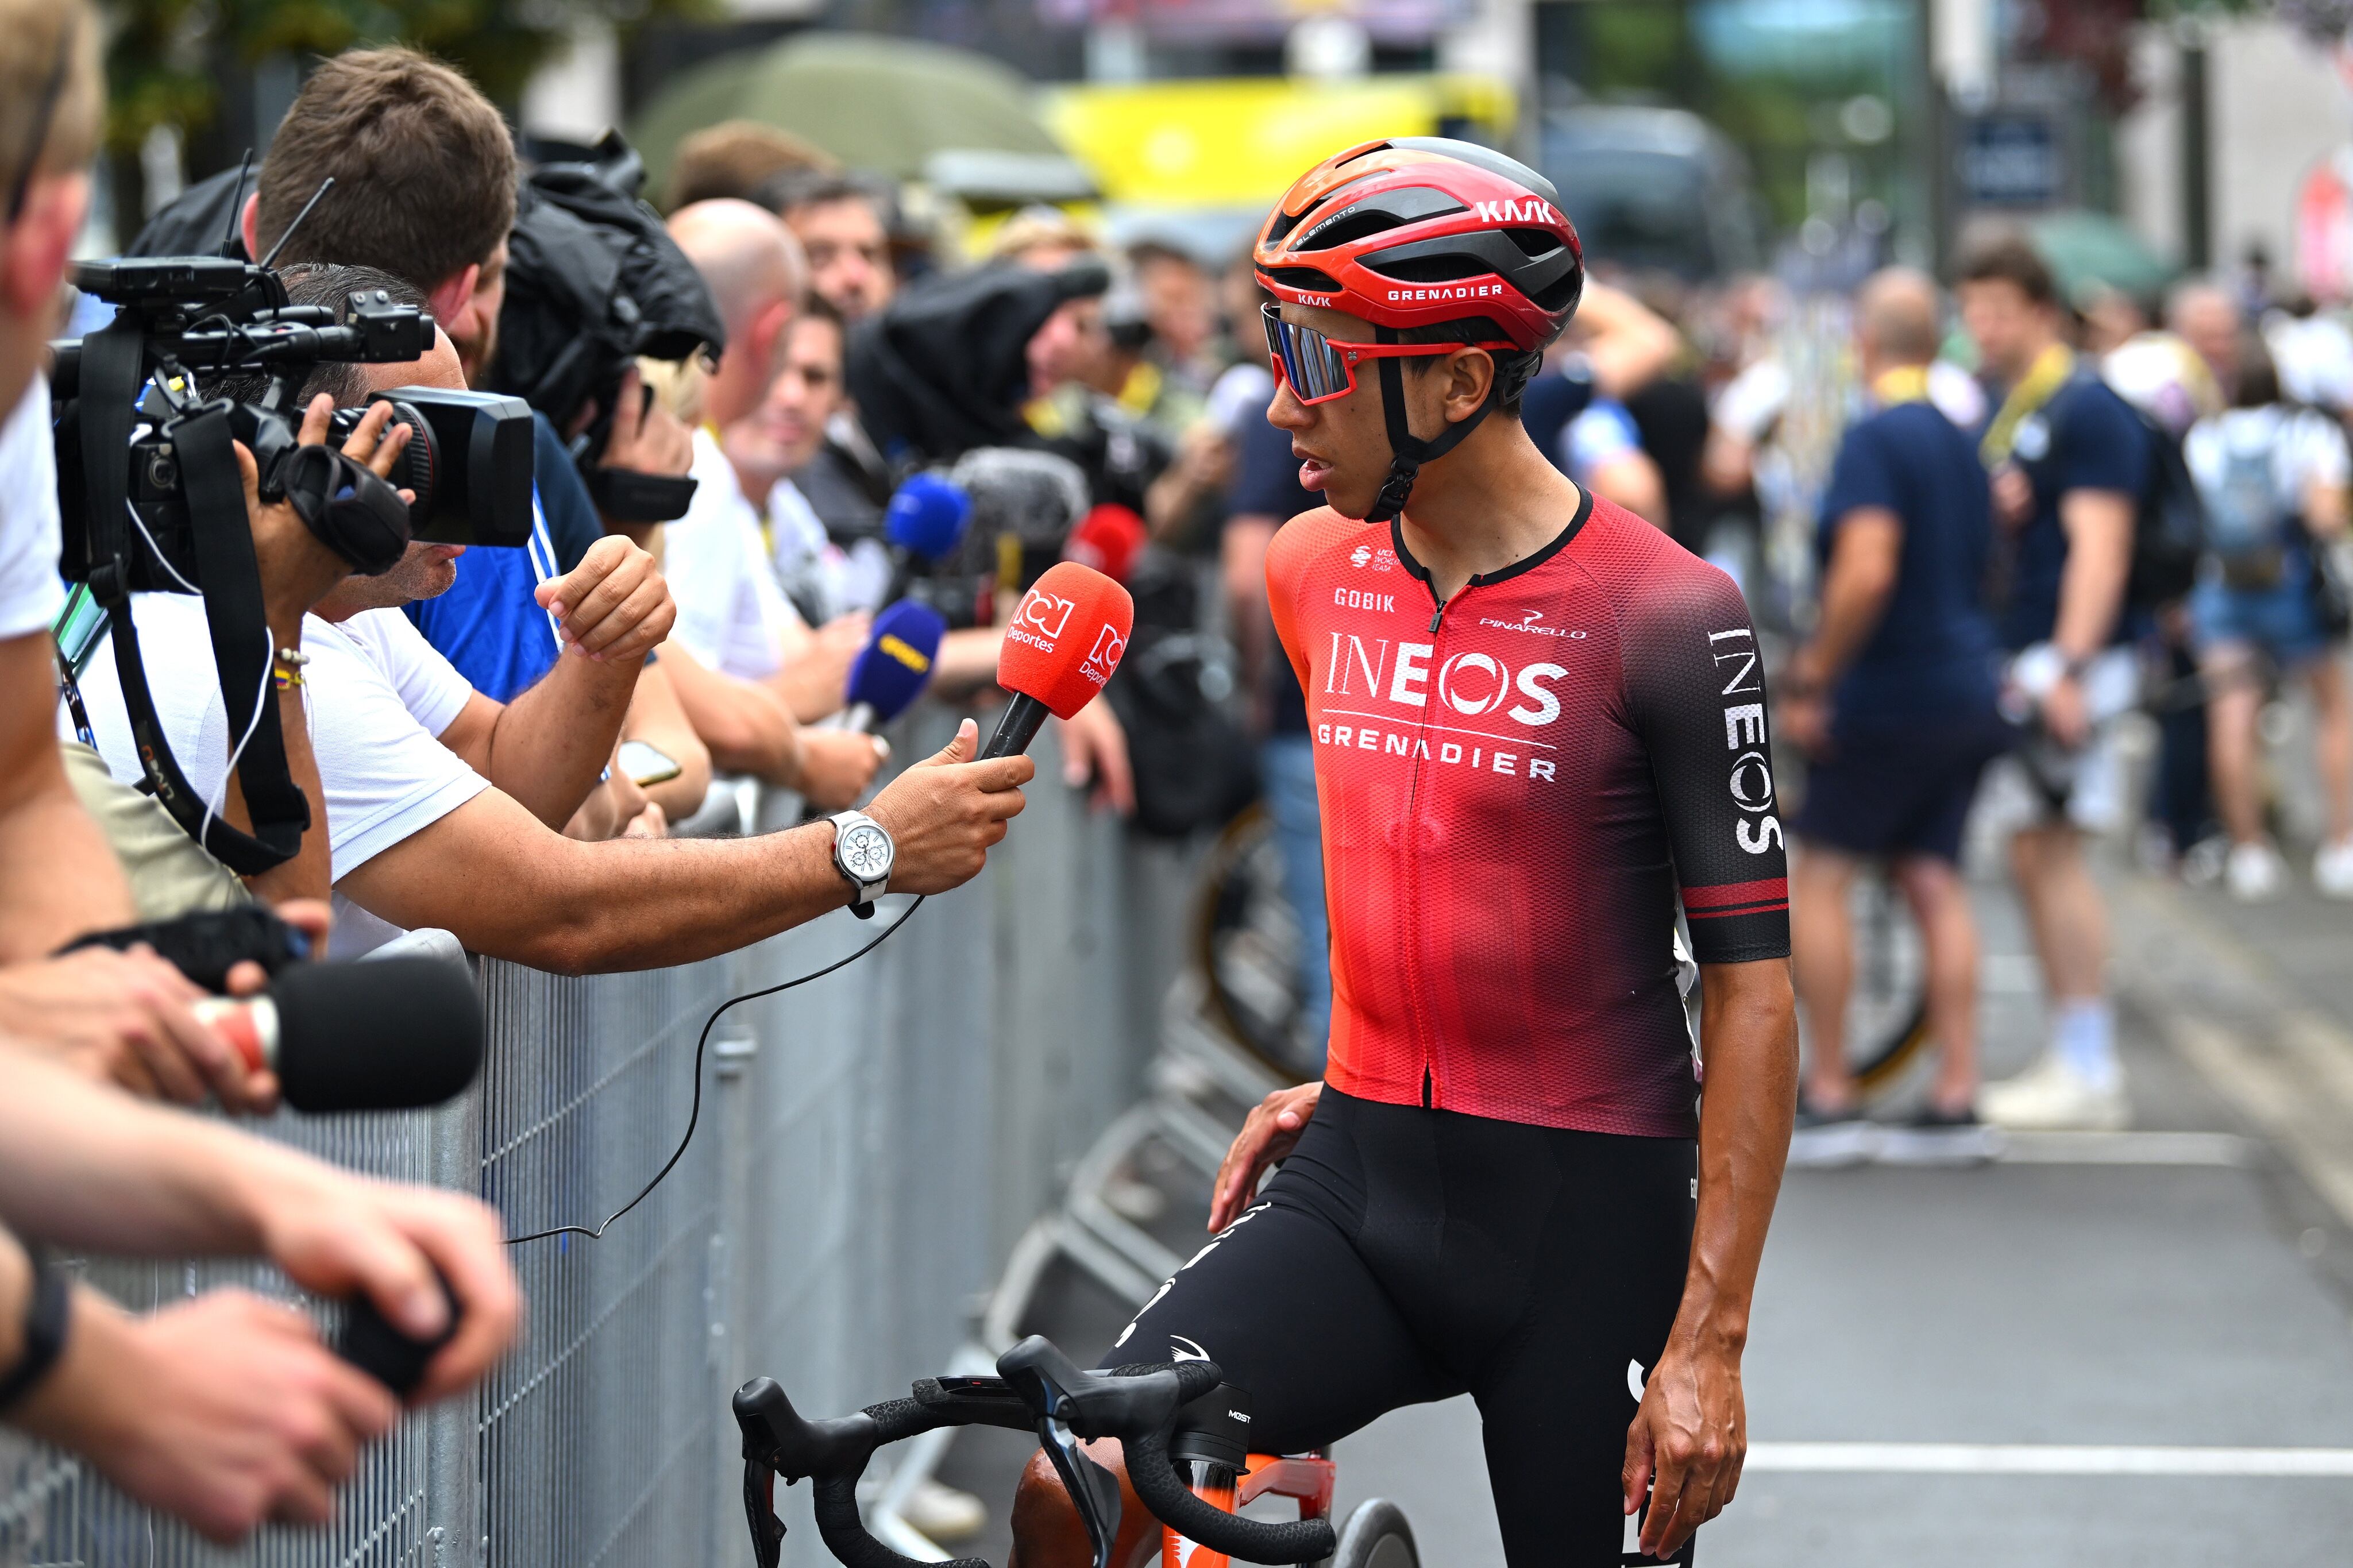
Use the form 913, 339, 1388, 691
1621, 553, 1788, 964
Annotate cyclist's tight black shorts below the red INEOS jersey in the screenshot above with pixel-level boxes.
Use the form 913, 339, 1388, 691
1099, 1088, 1699, 1568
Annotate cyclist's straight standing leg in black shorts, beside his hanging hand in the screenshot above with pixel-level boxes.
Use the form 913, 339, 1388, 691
1471, 1133, 1699, 1568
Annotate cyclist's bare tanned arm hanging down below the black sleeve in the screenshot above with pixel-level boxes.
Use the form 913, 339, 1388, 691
1623, 959, 1797, 1557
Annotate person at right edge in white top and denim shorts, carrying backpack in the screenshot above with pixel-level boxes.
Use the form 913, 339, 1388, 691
2181, 338, 2353, 901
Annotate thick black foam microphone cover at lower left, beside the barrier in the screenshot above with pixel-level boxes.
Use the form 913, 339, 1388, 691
268, 959, 483, 1112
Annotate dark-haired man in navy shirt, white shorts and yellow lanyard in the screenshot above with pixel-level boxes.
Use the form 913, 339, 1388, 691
1960, 240, 2151, 1129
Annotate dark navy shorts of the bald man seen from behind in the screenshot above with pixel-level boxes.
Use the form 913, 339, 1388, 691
1791, 712, 2014, 865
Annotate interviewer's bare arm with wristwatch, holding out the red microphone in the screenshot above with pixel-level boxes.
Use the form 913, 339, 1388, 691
337, 719, 1035, 973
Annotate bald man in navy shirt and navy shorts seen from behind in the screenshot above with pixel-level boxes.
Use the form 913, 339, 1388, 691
1779, 271, 2009, 1161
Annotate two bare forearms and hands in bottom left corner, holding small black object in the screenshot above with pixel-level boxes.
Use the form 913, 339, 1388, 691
0, 1044, 520, 1544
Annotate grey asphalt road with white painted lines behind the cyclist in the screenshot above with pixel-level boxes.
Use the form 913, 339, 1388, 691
943, 879, 2353, 1568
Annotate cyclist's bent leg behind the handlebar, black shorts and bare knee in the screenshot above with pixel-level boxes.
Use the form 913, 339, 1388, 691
1012, 1091, 1461, 1568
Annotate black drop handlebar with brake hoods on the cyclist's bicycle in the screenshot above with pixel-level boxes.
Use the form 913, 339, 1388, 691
734, 1335, 1337, 1568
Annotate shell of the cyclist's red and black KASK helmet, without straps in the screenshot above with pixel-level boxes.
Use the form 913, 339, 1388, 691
1252, 136, 1586, 350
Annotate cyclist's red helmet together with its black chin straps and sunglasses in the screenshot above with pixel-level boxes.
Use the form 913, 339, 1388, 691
1252, 136, 1586, 522
